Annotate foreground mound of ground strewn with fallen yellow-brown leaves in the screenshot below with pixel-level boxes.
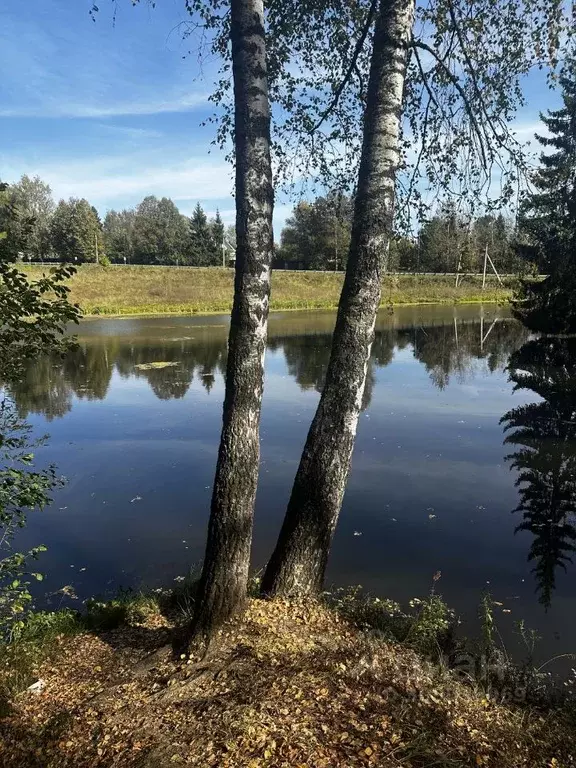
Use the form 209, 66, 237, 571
0, 600, 576, 768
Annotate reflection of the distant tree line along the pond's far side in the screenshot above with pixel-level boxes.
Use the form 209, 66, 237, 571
5, 315, 527, 420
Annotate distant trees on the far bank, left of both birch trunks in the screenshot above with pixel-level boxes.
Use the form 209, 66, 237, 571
0, 175, 235, 267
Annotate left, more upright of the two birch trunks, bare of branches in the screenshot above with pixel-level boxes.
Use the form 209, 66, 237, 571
192, 0, 273, 638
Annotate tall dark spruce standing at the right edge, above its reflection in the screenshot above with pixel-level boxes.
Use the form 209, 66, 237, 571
514, 58, 576, 333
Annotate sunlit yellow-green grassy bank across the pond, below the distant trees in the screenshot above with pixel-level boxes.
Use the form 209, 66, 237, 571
24, 265, 511, 315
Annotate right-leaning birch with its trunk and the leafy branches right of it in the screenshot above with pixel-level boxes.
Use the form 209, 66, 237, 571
262, 0, 571, 596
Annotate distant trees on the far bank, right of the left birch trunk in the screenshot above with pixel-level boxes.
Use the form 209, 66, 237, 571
275, 192, 523, 272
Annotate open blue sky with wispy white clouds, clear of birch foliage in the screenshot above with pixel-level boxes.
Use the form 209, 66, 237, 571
0, 0, 555, 237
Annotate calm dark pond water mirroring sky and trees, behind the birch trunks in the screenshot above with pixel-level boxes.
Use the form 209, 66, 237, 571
7, 307, 576, 658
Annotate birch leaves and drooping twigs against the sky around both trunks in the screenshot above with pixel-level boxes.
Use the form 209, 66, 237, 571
186, 0, 573, 226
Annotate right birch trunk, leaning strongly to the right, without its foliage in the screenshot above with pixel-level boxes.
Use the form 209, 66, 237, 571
262, 0, 415, 595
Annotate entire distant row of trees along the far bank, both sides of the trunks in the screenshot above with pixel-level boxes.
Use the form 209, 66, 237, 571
0, 171, 567, 273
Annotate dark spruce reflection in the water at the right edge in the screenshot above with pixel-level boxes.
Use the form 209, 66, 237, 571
502, 337, 576, 607
